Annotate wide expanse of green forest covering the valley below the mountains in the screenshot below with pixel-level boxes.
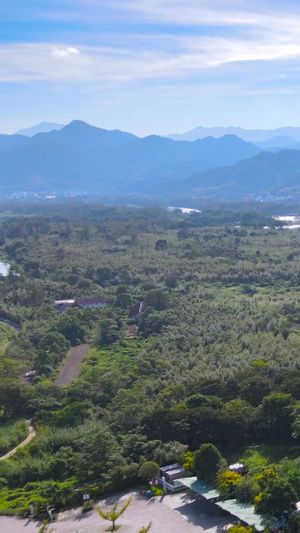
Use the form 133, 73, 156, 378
0, 201, 300, 514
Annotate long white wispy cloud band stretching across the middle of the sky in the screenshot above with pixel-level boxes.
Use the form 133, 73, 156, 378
0, 31, 300, 83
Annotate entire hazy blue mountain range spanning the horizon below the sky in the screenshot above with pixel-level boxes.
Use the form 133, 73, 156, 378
0, 120, 300, 199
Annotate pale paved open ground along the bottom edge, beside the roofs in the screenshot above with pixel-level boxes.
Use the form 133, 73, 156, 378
0, 492, 230, 533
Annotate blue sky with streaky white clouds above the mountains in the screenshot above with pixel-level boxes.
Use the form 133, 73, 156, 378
0, 0, 300, 135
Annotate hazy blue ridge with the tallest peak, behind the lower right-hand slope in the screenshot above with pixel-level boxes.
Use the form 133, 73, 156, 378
0, 120, 260, 195
